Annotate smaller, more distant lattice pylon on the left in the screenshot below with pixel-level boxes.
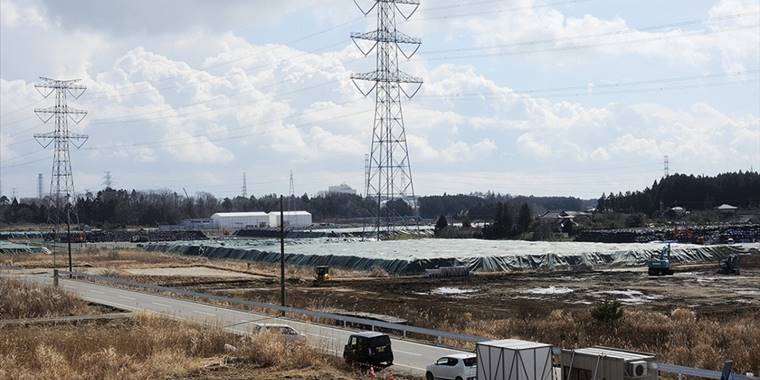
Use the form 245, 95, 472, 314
34, 77, 87, 227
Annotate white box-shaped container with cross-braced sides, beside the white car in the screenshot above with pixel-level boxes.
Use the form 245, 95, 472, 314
475, 339, 552, 380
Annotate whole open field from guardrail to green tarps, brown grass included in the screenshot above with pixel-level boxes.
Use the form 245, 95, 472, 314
0, 251, 760, 373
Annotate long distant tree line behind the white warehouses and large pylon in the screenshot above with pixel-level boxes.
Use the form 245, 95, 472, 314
0, 188, 585, 227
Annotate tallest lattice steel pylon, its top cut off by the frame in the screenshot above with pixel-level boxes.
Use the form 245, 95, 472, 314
351, 0, 422, 237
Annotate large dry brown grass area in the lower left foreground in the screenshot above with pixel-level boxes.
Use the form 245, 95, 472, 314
0, 315, 380, 380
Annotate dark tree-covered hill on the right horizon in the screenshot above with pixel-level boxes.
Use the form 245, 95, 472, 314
597, 171, 760, 215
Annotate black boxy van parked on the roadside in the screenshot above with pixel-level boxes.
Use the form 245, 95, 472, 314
343, 331, 393, 368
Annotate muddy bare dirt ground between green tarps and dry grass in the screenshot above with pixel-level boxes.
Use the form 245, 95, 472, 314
0, 246, 760, 327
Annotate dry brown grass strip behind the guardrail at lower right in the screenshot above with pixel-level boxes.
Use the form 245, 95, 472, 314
449, 309, 760, 371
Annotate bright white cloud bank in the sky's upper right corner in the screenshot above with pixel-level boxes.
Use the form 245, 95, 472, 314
440, 0, 760, 71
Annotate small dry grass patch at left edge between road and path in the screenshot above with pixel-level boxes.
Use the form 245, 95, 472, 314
0, 278, 94, 319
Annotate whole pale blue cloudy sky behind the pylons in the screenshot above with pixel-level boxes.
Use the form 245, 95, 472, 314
0, 0, 760, 198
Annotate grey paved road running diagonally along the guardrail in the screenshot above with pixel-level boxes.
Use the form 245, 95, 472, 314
11, 275, 460, 375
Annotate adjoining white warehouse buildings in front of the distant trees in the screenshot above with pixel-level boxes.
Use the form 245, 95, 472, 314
211, 211, 311, 231
